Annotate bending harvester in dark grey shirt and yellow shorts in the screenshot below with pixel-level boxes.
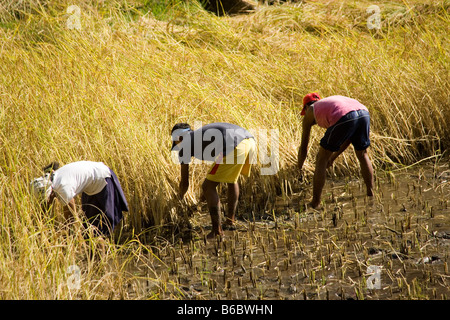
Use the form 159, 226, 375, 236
171, 122, 256, 238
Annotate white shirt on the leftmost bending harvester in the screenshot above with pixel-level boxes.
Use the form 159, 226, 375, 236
52, 161, 111, 205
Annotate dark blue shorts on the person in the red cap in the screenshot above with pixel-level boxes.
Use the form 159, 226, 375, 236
320, 110, 370, 152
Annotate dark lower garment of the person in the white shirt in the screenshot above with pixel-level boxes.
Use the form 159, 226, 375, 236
81, 170, 128, 235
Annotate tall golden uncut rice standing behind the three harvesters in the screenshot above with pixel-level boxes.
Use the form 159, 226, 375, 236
0, 0, 450, 298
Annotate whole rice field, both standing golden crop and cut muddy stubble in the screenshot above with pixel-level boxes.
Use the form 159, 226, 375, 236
0, 0, 450, 300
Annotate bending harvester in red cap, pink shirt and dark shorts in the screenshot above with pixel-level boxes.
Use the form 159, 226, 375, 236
298, 92, 373, 208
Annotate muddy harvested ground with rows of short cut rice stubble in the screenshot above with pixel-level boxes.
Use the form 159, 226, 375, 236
130, 163, 450, 300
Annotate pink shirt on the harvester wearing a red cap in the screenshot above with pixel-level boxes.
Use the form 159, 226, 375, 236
313, 96, 367, 128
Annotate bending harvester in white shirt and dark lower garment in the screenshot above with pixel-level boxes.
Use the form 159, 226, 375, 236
32, 161, 128, 235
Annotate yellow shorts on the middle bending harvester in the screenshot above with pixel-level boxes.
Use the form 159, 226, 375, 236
206, 138, 256, 183
